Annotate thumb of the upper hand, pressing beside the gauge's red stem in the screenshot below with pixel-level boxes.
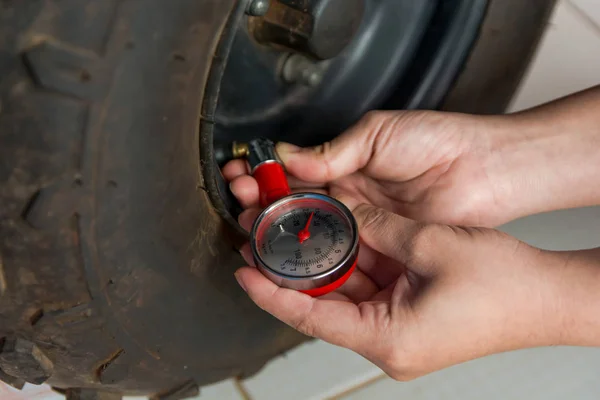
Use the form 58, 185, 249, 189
277, 111, 395, 183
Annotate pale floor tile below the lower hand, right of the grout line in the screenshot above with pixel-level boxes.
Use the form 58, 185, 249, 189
340, 348, 600, 400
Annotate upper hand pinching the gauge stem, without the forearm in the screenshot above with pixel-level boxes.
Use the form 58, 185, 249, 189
223, 111, 506, 226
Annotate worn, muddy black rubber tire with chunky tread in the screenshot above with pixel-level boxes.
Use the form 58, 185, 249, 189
0, 0, 552, 399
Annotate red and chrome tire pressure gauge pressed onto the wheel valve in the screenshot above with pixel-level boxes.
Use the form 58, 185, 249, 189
248, 139, 358, 297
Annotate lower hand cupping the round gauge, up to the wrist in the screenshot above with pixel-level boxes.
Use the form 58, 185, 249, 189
236, 202, 568, 380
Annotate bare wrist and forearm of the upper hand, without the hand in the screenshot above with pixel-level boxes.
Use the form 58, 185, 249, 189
484, 106, 600, 222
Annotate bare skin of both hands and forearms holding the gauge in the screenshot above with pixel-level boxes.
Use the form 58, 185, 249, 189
223, 88, 600, 380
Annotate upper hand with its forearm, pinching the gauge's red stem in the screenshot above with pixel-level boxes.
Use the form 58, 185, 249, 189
224, 87, 600, 227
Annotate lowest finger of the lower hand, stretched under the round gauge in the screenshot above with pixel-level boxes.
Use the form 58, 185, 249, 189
235, 267, 366, 349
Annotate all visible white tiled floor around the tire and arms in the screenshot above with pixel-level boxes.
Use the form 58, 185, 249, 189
0, 0, 600, 400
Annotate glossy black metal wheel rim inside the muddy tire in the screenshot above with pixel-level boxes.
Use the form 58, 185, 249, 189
201, 0, 488, 233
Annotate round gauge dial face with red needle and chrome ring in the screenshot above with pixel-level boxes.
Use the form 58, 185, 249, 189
253, 194, 356, 278
